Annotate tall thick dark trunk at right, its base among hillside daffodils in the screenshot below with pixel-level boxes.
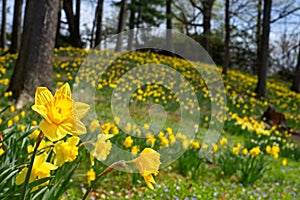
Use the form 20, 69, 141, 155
255, 0, 272, 98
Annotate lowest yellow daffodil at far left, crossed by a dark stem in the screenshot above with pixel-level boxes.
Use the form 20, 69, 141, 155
16, 153, 57, 185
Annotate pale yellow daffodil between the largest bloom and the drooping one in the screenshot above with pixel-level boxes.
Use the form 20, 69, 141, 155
91, 134, 113, 161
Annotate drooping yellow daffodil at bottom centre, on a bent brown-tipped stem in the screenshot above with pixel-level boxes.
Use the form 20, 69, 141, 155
129, 148, 161, 189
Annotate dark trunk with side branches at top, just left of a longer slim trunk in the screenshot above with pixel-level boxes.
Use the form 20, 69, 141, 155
202, 0, 214, 53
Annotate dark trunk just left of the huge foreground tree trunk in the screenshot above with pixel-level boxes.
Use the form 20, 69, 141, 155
9, 0, 23, 53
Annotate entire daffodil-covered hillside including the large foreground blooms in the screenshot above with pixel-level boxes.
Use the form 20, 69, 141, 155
0, 47, 300, 199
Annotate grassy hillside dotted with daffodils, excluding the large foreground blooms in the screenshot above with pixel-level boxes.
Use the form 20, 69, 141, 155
0, 48, 300, 199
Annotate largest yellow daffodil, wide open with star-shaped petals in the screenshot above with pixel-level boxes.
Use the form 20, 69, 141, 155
32, 83, 89, 141
